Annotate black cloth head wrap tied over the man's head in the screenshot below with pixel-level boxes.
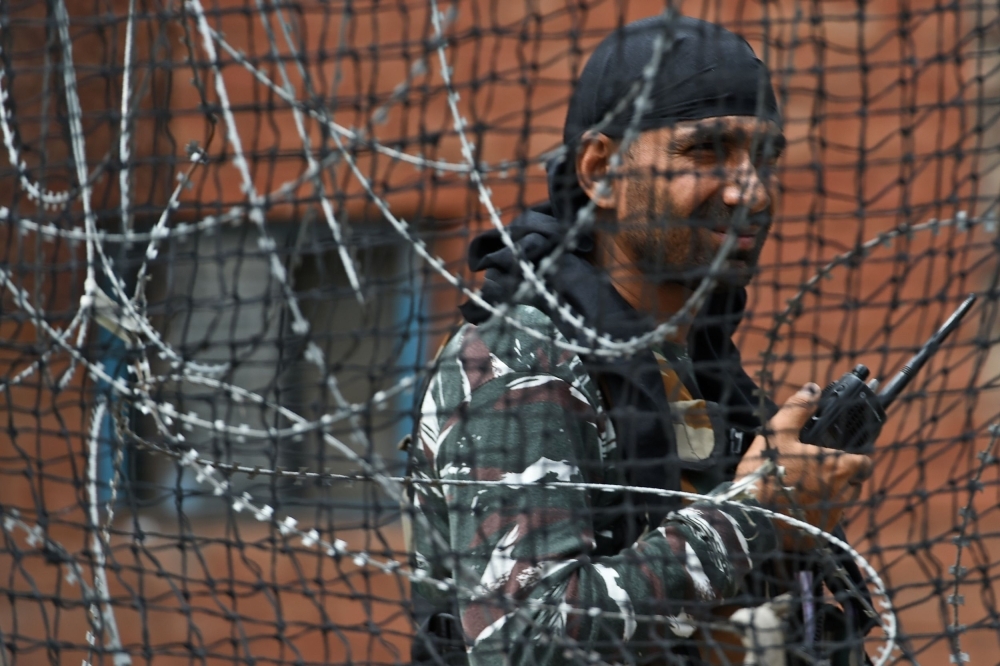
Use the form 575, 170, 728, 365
549, 16, 781, 222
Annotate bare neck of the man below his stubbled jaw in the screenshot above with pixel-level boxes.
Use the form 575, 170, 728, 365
594, 233, 691, 345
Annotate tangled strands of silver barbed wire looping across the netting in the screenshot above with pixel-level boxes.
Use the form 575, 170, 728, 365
0, 0, 996, 665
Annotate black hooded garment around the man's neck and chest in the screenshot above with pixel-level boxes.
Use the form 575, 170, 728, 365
462, 204, 776, 538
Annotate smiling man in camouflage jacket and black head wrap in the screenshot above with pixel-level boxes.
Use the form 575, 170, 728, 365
410, 17, 870, 664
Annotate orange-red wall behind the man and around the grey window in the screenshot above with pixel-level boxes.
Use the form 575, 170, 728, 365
0, 0, 1000, 663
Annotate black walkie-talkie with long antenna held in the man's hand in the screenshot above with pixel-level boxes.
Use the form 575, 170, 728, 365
799, 294, 976, 453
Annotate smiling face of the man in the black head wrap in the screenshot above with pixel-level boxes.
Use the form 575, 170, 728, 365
616, 116, 785, 286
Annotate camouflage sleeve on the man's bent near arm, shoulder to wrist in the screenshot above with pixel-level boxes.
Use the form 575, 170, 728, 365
427, 316, 776, 664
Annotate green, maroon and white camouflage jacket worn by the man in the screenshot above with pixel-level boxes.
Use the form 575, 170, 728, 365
411, 305, 776, 665
